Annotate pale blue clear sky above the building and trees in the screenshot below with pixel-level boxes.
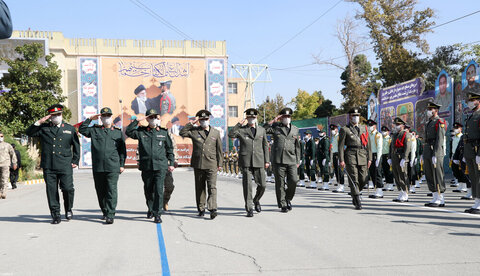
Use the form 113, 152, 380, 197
5, 0, 480, 107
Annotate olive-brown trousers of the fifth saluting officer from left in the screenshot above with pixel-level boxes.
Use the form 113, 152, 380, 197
241, 167, 267, 211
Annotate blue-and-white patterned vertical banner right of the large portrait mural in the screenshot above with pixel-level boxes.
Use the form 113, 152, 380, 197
206, 58, 228, 151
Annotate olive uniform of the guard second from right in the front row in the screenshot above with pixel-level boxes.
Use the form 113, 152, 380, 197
423, 116, 446, 193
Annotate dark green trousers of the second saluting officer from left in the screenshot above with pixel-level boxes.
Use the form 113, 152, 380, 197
93, 172, 120, 218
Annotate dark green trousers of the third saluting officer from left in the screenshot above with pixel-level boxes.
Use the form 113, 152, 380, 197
142, 166, 167, 217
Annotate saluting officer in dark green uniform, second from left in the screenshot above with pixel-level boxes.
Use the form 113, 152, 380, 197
78, 107, 127, 224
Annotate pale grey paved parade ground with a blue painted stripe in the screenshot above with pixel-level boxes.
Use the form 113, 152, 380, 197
0, 168, 480, 275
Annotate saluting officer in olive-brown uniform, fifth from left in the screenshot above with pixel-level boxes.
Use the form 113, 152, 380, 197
228, 108, 270, 217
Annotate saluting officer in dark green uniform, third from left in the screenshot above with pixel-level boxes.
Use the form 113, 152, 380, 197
125, 108, 175, 223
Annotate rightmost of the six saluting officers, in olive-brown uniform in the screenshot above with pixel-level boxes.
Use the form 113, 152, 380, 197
265, 107, 301, 213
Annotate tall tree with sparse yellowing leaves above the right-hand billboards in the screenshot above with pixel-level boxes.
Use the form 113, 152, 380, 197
354, 0, 435, 86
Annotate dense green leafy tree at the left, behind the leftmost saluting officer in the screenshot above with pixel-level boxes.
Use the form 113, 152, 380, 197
0, 43, 71, 134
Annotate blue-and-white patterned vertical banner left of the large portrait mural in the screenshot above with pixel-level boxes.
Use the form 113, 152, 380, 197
78, 58, 100, 168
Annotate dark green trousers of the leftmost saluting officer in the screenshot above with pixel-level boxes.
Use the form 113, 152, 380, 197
43, 169, 75, 218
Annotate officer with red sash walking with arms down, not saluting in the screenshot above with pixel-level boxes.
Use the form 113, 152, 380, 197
338, 108, 372, 210
